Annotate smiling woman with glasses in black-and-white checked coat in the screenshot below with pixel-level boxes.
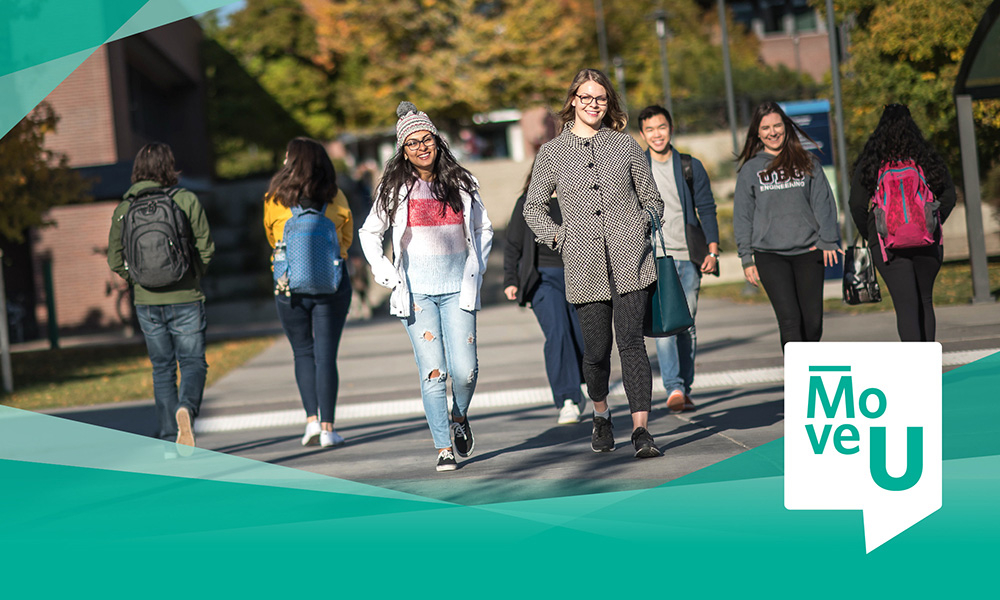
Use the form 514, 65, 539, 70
524, 69, 663, 458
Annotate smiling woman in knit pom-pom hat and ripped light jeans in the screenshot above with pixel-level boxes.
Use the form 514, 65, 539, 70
358, 102, 493, 471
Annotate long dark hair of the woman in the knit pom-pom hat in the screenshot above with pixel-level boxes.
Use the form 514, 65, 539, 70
375, 134, 476, 222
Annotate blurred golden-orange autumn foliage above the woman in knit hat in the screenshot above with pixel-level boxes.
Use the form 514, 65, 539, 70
303, 0, 596, 127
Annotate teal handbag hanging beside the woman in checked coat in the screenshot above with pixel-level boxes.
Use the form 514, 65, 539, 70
643, 208, 694, 337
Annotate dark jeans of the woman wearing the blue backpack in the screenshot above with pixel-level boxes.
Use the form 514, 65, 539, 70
275, 273, 351, 423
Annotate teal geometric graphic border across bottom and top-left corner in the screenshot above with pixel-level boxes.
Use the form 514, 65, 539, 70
0, 0, 1000, 599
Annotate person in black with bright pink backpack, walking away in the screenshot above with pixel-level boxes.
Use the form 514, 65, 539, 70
850, 104, 955, 342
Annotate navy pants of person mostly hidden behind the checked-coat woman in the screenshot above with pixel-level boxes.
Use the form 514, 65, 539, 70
531, 267, 583, 408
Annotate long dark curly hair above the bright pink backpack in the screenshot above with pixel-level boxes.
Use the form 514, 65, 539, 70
854, 104, 948, 196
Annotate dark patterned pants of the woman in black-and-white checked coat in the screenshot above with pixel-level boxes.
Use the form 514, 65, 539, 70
576, 284, 653, 413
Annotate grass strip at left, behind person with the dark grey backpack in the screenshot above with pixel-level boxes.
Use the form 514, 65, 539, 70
0, 337, 275, 410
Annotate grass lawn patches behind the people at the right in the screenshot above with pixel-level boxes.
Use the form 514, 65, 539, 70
699, 261, 1000, 314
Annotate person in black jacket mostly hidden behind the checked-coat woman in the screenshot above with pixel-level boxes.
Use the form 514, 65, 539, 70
503, 166, 584, 425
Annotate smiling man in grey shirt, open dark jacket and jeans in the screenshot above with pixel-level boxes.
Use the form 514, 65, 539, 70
639, 105, 719, 412
